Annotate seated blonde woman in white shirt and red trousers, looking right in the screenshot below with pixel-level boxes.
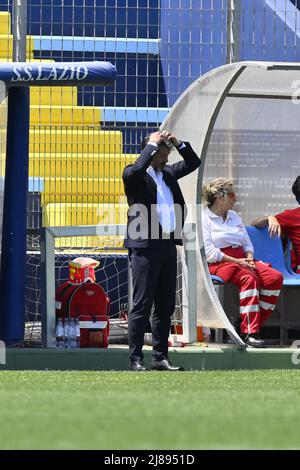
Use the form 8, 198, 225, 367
203, 178, 283, 348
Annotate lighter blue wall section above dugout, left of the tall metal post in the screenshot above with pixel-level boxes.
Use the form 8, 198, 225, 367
160, 0, 226, 106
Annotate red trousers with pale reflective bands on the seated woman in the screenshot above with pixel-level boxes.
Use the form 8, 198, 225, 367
208, 247, 283, 334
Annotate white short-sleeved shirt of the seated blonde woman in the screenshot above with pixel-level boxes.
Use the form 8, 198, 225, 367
202, 207, 254, 263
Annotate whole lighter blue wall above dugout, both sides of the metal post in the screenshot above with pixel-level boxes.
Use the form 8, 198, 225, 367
160, 0, 300, 106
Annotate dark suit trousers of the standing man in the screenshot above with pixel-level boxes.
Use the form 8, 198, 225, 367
128, 240, 177, 361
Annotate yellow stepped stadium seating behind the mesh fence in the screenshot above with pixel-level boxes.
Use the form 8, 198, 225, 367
0, 17, 132, 242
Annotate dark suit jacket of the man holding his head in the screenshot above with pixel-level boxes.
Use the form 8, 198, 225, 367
123, 142, 200, 248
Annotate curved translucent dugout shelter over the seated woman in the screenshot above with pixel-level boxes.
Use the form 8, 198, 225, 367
162, 62, 300, 345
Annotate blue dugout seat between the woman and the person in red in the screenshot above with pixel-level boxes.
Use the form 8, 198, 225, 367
246, 227, 300, 344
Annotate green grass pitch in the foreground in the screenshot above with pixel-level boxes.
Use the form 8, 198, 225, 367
0, 370, 300, 450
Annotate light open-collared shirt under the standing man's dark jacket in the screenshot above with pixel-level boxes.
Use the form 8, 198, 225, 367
147, 166, 176, 233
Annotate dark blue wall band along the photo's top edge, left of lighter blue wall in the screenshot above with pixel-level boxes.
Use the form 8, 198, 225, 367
26, 0, 159, 38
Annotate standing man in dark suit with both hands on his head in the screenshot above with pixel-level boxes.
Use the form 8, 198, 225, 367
123, 130, 200, 371
